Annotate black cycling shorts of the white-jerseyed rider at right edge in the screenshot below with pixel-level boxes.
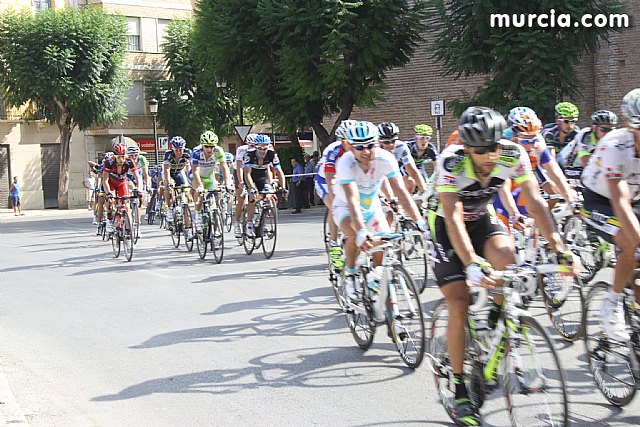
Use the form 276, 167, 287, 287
580, 188, 640, 243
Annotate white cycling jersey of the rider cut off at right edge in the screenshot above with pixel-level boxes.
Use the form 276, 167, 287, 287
582, 129, 640, 201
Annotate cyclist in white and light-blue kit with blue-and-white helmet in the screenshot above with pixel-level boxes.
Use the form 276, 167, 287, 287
333, 121, 426, 302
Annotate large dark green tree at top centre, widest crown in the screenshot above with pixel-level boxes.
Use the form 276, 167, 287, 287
194, 0, 425, 150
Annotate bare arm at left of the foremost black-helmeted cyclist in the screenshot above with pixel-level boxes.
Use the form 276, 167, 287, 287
438, 192, 478, 267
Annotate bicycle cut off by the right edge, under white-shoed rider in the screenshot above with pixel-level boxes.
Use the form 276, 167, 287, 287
584, 268, 640, 407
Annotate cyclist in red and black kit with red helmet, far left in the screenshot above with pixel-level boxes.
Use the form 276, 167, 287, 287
102, 144, 140, 233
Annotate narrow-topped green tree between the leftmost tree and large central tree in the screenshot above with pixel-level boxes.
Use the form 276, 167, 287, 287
147, 20, 237, 147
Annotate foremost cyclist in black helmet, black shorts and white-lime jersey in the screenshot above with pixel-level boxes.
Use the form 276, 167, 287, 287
429, 107, 573, 425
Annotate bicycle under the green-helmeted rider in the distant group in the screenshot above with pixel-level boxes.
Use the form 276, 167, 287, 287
196, 190, 224, 264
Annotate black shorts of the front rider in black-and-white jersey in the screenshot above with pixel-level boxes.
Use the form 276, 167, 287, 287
429, 213, 508, 287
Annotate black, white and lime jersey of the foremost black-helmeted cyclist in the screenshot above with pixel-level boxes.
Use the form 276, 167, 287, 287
430, 140, 533, 221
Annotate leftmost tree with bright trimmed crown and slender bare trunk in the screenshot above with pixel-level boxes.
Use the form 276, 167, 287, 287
0, 8, 130, 209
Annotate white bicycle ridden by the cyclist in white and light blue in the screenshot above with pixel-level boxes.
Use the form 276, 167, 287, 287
339, 234, 425, 368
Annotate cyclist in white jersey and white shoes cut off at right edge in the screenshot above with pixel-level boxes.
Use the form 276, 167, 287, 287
582, 89, 640, 342
